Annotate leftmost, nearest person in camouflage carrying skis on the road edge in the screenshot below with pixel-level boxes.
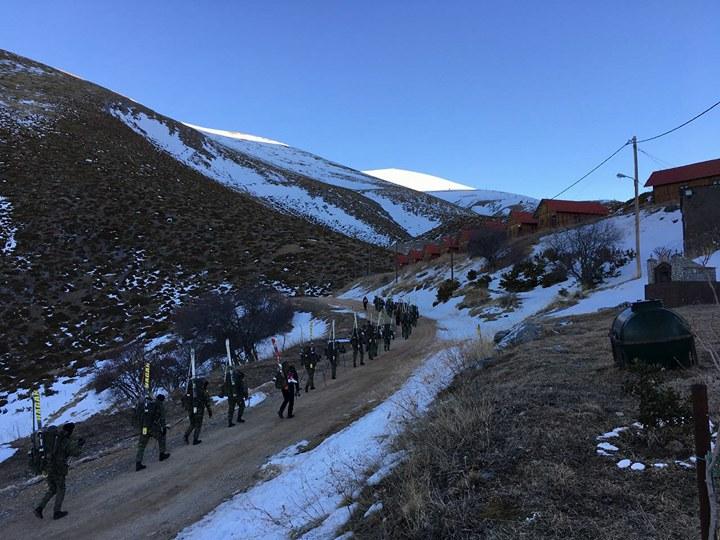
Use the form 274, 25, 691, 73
34, 422, 85, 519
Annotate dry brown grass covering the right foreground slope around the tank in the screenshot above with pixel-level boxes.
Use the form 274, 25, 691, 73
350, 308, 718, 540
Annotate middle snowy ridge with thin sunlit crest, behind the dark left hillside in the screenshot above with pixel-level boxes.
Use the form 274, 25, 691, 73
186, 124, 472, 236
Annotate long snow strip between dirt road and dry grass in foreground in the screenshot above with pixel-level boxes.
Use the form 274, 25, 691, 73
178, 354, 452, 540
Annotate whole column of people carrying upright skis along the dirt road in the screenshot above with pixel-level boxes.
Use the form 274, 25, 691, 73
29, 297, 419, 519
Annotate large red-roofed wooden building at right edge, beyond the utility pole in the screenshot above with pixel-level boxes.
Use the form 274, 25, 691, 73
645, 159, 720, 203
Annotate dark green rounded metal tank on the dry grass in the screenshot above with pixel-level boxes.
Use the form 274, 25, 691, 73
610, 300, 697, 369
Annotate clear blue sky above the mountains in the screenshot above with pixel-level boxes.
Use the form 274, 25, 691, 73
0, 0, 720, 199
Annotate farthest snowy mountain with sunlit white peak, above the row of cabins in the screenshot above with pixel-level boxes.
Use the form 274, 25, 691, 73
365, 169, 539, 216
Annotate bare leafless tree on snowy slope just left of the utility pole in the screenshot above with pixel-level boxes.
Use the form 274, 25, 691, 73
548, 221, 633, 289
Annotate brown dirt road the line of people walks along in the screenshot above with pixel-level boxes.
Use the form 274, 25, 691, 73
0, 299, 439, 540
